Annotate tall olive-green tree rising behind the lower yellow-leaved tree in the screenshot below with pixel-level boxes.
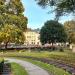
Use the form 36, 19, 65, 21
0, 0, 28, 31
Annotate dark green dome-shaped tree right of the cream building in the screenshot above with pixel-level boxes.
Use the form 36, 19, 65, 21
40, 20, 67, 44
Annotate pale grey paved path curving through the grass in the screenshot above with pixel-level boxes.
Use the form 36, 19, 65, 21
5, 58, 49, 75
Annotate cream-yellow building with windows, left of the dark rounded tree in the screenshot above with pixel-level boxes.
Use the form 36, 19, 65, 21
24, 30, 41, 45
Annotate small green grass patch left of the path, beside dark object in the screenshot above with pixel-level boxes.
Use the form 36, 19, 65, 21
11, 63, 28, 75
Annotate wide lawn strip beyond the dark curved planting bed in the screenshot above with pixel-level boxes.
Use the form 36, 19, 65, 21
0, 50, 75, 66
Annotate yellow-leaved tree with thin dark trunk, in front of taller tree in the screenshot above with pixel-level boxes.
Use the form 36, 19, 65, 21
0, 24, 25, 49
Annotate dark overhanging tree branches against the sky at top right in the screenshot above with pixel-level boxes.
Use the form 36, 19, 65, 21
36, 0, 75, 20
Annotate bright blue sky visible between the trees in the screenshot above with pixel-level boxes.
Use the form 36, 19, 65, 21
22, 0, 72, 29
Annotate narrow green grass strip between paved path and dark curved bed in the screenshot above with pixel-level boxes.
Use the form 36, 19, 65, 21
13, 58, 71, 75
